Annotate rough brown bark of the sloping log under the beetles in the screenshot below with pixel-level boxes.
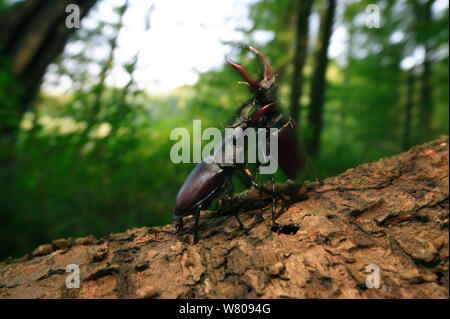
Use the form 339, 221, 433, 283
0, 136, 449, 298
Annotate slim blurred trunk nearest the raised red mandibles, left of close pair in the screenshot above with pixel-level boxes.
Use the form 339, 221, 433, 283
290, 0, 312, 125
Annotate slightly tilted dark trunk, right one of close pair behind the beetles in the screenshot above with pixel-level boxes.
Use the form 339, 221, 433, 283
308, 0, 336, 157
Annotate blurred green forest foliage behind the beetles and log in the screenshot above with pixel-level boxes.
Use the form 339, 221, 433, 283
0, 0, 449, 259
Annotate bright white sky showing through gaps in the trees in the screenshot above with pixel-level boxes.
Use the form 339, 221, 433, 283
44, 0, 448, 93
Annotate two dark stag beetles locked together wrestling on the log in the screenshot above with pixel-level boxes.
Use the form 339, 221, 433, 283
173, 46, 305, 243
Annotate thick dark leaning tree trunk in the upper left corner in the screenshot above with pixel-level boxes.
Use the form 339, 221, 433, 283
0, 0, 97, 141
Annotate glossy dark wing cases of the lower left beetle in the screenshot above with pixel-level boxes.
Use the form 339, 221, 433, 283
173, 159, 229, 219
